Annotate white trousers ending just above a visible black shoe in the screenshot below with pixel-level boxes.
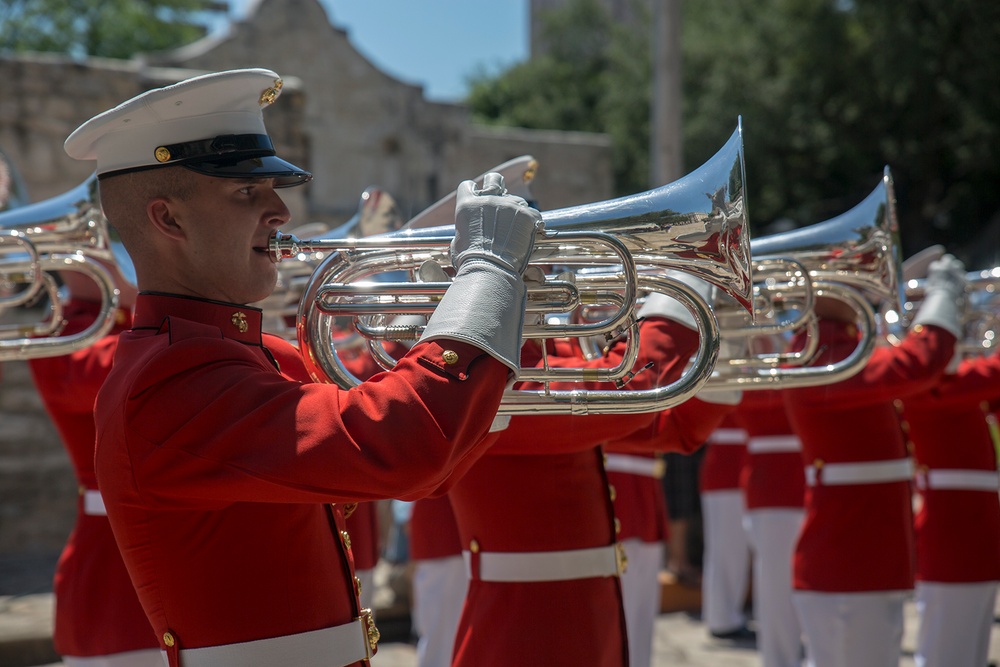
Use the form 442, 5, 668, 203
701, 489, 750, 632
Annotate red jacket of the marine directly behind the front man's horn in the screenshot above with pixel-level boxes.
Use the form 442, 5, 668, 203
450, 319, 697, 667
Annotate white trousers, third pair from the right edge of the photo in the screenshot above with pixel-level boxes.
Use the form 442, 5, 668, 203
745, 507, 805, 667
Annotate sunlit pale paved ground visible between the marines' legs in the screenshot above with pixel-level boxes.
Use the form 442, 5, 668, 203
0, 557, 1000, 667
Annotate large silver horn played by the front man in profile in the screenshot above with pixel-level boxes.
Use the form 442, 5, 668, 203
270, 120, 752, 415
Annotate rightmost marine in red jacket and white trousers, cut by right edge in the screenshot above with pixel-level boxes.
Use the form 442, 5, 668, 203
897, 354, 1000, 667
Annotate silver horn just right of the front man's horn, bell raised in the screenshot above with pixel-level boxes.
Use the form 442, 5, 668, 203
706, 167, 904, 390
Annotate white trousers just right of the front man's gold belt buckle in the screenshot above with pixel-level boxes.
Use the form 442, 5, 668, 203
413, 555, 469, 667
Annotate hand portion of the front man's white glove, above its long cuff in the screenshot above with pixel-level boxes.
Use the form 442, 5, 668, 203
451, 172, 542, 274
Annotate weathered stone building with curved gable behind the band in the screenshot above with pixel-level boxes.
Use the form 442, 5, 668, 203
0, 0, 612, 560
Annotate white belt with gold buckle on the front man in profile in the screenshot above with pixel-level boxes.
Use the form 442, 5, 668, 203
170, 610, 378, 667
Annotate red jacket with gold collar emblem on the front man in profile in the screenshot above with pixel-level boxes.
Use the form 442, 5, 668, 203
96, 294, 507, 666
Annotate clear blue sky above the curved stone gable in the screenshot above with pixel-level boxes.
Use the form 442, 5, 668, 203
219, 0, 528, 101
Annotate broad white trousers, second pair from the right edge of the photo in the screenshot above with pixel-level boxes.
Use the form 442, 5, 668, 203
792, 591, 907, 667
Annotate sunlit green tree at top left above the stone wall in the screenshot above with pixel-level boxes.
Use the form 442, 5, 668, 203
0, 0, 226, 58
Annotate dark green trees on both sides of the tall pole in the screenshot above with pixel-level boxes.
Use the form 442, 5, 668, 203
469, 0, 1000, 263
